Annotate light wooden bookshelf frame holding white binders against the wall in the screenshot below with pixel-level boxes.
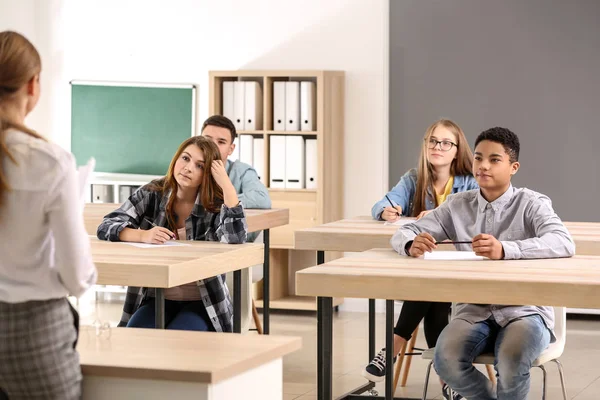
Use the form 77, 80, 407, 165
209, 70, 345, 310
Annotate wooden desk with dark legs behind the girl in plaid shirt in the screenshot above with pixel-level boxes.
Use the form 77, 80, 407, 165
83, 203, 290, 334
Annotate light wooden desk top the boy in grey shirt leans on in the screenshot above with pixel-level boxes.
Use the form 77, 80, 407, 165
296, 249, 600, 308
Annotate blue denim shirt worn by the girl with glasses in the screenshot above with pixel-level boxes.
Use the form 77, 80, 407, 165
371, 168, 479, 220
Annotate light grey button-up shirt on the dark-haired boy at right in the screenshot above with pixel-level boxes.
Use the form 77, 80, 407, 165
391, 185, 575, 336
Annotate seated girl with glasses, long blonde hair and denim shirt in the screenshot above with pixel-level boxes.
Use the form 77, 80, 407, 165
363, 119, 478, 398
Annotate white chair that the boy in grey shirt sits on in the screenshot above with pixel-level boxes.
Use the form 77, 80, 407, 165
422, 307, 567, 400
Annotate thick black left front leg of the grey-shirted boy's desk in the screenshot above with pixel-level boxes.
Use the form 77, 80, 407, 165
317, 297, 333, 400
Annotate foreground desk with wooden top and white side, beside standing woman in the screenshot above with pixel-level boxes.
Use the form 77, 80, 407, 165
77, 327, 301, 400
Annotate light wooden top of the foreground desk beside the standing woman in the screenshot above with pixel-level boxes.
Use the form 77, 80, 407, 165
77, 327, 302, 384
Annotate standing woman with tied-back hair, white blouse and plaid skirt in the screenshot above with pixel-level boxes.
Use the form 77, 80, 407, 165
0, 31, 96, 400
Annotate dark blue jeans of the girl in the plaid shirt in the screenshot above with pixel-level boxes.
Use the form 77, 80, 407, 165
127, 297, 214, 332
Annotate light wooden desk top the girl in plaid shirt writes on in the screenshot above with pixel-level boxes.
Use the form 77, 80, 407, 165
90, 237, 264, 288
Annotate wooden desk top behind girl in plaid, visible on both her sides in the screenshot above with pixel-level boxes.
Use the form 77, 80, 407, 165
83, 203, 290, 235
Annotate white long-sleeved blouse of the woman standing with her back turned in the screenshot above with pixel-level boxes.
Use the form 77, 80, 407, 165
0, 130, 97, 303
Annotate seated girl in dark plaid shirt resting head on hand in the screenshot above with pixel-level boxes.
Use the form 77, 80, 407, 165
97, 136, 247, 332
